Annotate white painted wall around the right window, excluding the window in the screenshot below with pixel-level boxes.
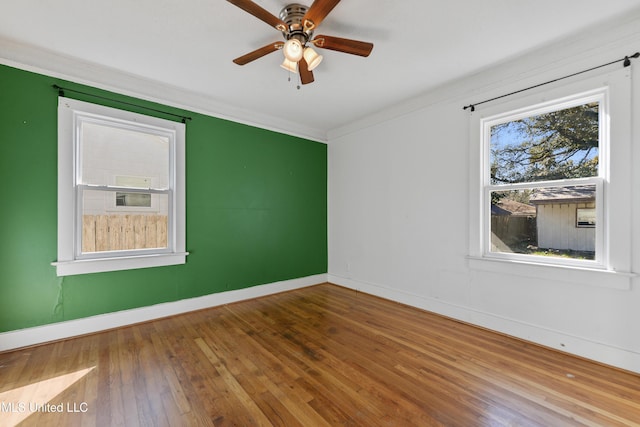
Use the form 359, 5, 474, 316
329, 11, 640, 372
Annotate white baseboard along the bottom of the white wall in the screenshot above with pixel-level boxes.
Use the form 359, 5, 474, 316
328, 274, 640, 373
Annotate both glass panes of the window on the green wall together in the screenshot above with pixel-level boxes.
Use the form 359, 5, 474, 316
78, 118, 170, 257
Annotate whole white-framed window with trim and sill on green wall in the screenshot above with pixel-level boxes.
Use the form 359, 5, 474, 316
54, 97, 187, 276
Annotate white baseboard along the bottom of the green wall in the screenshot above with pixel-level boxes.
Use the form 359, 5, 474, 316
0, 274, 327, 351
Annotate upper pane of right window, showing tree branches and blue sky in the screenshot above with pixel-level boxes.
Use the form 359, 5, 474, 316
490, 102, 599, 185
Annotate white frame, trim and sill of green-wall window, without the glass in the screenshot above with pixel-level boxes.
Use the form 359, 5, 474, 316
52, 97, 188, 276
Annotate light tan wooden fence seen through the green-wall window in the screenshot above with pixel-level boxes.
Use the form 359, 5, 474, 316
82, 215, 167, 252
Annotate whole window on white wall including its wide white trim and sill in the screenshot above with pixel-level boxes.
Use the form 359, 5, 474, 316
469, 68, 633, 289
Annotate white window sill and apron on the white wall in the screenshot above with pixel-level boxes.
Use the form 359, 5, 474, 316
467, 256, 637, 291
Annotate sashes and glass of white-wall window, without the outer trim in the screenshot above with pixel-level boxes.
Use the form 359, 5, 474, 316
482, 93, 608, 264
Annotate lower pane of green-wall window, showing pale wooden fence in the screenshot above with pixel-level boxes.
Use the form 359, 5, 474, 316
81, 190, 169, 253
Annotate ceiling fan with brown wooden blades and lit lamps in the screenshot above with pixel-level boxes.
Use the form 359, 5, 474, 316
227, 0, 373, 85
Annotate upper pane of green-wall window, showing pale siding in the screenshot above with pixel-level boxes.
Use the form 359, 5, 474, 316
80, 122, 170, 189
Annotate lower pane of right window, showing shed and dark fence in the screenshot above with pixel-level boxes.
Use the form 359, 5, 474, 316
491, 185, 597, 260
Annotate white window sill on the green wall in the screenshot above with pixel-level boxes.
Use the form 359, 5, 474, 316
51, 252, 189, 276
